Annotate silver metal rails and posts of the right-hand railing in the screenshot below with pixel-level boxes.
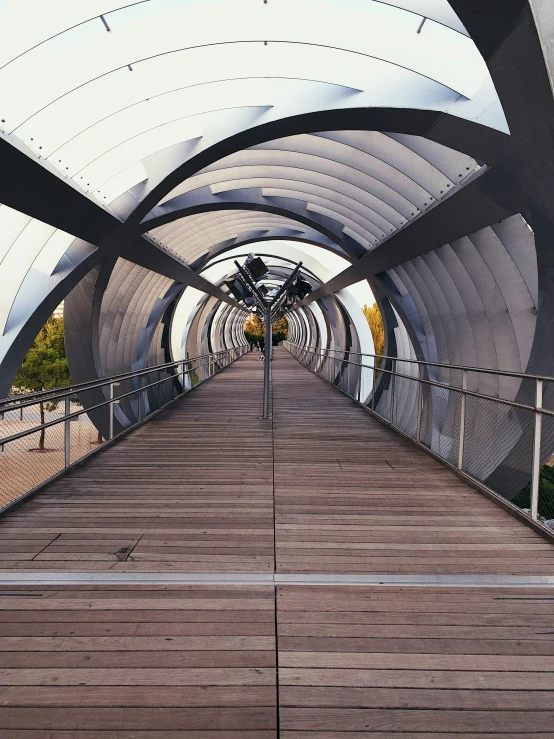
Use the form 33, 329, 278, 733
283, 341, 554, 521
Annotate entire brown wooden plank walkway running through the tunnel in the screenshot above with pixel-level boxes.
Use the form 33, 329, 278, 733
0, 349, 554, 739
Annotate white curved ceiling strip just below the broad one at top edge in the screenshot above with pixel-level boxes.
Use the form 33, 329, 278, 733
8, 43, 448, 156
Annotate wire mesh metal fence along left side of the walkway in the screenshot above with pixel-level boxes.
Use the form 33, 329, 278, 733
0, 347, 248, 513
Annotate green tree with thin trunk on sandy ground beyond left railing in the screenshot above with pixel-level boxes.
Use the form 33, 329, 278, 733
14, 316, 71, 452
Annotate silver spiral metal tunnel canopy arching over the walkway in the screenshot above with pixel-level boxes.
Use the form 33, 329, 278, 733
5, 0, 554, 520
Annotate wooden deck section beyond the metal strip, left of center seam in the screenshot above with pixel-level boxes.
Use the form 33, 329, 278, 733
0, 357, 274, 573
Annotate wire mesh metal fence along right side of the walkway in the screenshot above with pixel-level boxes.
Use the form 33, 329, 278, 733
284, 341, 554, 529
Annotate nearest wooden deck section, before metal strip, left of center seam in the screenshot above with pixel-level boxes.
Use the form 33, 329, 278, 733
0, 584, 277, 739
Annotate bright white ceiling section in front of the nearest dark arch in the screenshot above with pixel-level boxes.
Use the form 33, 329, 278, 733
0, 0, 504, 217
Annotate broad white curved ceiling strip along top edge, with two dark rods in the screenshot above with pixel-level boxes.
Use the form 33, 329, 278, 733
0, 0, 487, 122
